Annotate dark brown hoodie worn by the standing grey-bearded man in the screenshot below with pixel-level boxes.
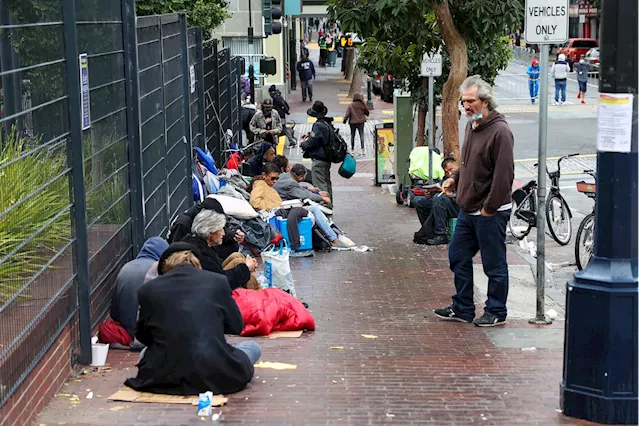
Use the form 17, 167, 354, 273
451, 111, 514, 214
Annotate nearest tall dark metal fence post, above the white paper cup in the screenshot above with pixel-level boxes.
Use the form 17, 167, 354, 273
63, 0, 91, 364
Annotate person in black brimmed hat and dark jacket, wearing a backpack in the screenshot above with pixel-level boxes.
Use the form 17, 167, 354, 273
300, 101, 333, 206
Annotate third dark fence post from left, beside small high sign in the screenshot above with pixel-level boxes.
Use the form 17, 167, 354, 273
179, 12, 193, 211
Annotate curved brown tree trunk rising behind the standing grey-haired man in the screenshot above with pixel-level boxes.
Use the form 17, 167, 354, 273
434, 0, 469, 160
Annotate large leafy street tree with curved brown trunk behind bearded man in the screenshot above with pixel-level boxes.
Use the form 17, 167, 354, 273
329, 0, 524, 158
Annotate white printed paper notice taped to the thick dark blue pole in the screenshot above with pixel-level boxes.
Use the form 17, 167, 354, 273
596, 93, 633, 152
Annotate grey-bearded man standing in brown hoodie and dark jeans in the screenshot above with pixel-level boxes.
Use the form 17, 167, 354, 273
434, 75, 514, 327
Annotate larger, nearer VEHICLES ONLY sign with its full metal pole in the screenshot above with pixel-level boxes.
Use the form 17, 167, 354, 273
524, 0, 569, 324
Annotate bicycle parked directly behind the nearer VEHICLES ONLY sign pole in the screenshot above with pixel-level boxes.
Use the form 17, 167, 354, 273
509, 154, 578, 246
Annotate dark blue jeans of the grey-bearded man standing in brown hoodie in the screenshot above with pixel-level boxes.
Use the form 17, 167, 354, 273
449, 211, 511, 321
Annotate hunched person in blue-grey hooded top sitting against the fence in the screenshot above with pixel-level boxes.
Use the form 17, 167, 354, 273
110, 237, 169, 339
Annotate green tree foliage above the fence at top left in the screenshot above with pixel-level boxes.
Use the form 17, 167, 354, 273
136, 0, 231, 33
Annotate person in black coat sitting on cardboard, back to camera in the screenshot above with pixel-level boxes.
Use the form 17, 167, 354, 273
125, 244, 262, 395
